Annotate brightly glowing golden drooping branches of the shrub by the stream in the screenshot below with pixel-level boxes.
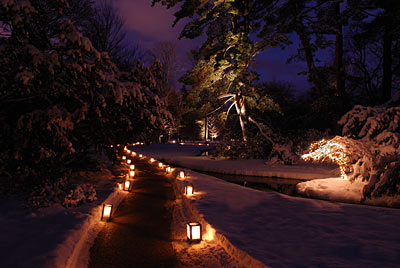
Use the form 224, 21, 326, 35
301, 139, 347, 179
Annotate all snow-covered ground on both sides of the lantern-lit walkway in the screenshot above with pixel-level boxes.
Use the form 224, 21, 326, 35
0, 145, 400, 267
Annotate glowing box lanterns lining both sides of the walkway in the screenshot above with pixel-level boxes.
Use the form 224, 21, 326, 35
101, 146, 202, 242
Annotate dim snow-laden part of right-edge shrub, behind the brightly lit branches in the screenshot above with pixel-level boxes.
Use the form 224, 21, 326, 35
339, 105, 400, 197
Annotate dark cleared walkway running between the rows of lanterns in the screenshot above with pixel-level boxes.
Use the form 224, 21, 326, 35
88, 160, 179, 268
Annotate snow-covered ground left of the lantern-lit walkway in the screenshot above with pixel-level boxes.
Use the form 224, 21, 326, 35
0, 161, 125, 268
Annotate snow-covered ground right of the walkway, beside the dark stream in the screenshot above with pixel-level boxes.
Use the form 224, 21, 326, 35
134, 145, 400, 267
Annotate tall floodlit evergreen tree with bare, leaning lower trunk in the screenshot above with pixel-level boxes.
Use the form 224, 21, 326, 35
153, 0, 296, 161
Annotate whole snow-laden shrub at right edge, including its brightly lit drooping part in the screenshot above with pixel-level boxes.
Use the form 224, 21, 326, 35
303, 105, 400, 202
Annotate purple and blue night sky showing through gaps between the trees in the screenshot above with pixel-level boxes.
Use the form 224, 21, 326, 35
112, 0, 310, 93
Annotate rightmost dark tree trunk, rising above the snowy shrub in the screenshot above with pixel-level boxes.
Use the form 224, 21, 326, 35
381, 23, 393, 103
